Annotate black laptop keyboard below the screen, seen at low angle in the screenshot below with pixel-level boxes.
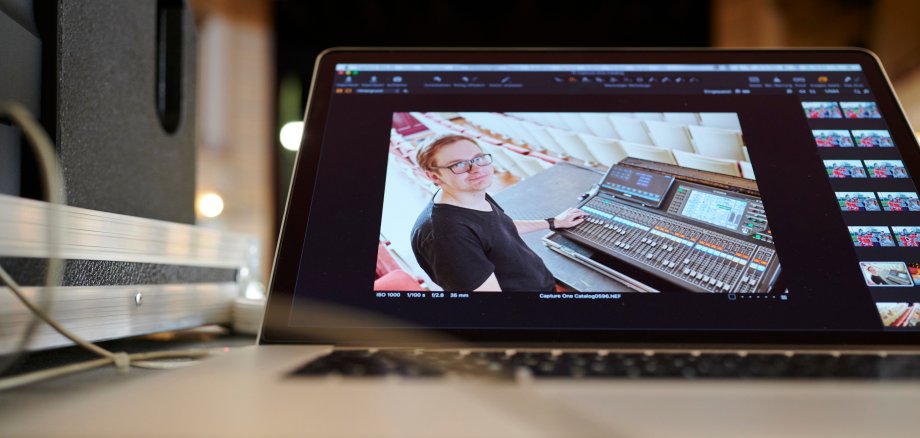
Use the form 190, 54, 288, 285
293, 350, 920, 379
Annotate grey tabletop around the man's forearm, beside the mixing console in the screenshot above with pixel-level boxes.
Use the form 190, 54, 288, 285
493, 162, 631, 292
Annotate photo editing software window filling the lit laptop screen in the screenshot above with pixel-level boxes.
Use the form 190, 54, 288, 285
295, 60, 920, 331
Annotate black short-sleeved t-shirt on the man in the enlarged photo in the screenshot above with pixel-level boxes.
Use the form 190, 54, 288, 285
412, 195, 555, 292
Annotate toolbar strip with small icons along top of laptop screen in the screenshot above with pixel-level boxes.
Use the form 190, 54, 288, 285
335, 64, 871, 96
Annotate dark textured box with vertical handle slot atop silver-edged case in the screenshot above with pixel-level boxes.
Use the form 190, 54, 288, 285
42, 0, 196, 223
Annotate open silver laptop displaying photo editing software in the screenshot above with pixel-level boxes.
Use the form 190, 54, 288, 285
10, 49, 920, 436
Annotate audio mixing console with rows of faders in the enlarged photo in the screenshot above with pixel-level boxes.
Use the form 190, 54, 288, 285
559, 162, 780, 293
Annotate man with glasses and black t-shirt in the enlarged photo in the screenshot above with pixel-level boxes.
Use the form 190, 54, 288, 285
412, 135, 585, 292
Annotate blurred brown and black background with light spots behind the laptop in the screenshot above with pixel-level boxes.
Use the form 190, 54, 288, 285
7, 0, 920, 280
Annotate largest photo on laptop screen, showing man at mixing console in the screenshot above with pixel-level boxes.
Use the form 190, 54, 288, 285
374, 112, 780, 293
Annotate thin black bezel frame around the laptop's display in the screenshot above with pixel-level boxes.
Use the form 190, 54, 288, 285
259, 48, 920, 346
